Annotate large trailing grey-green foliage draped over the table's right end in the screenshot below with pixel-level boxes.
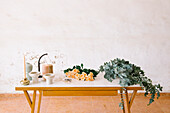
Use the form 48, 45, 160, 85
99, 58, 163, 105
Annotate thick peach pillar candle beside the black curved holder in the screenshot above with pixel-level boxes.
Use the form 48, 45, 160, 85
42, 64, 53, 74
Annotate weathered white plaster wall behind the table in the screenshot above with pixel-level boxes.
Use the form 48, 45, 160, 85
0, 0, 170, 93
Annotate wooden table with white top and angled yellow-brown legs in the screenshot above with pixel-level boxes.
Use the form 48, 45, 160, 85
15, 74, 142, 113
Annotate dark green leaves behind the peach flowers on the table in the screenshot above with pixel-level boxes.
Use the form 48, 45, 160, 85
64, 64, 99, 78
